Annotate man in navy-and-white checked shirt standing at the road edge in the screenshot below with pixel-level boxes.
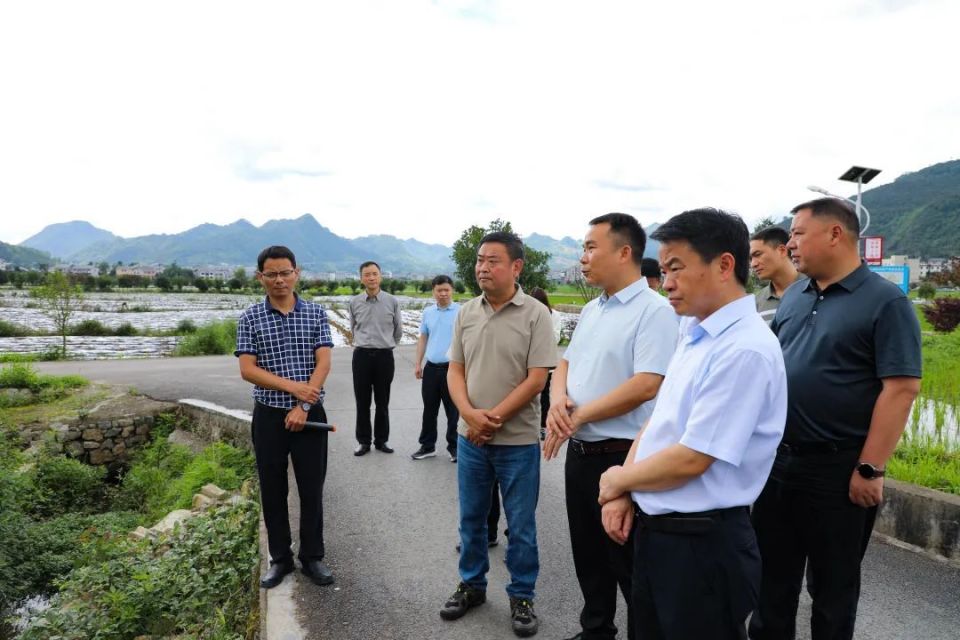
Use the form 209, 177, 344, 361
234, 246, 333, 589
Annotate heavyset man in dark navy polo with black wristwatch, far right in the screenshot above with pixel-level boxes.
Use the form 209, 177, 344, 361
750, 198, 921, 640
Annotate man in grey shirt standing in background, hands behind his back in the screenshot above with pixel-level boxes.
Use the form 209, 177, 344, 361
350, 261, 403, 456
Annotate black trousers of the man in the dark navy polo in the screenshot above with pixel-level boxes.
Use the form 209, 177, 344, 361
750, 448, 877, 640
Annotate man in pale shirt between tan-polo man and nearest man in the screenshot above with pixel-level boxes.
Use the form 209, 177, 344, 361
543, 213, 678, 639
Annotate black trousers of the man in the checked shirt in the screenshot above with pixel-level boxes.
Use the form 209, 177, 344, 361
251, 403, 327, 562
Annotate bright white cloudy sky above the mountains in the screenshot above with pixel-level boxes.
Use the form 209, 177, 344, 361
0, 0, 960, 244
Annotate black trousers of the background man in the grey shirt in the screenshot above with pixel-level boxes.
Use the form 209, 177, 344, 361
353, 347, 393, 446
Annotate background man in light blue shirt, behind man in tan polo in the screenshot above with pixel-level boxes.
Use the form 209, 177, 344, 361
410, 275, 460, 462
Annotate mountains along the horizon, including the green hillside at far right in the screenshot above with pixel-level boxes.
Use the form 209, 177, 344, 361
15, 160, 960, 275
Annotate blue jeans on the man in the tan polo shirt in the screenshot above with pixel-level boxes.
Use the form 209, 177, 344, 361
457, 436, 540, 600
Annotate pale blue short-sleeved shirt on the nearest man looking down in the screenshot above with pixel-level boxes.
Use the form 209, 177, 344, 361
632, 295, 787, 515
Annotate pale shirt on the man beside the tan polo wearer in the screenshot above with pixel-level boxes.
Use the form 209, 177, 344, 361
563, 278, 680, 442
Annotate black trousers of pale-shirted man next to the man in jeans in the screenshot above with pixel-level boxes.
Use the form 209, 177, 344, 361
564, 445, 633, 640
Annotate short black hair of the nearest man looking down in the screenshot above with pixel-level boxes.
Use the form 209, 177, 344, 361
650, 207, 750, 286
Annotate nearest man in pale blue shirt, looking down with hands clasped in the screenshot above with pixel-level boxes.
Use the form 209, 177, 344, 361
600, 209, 787, 639
